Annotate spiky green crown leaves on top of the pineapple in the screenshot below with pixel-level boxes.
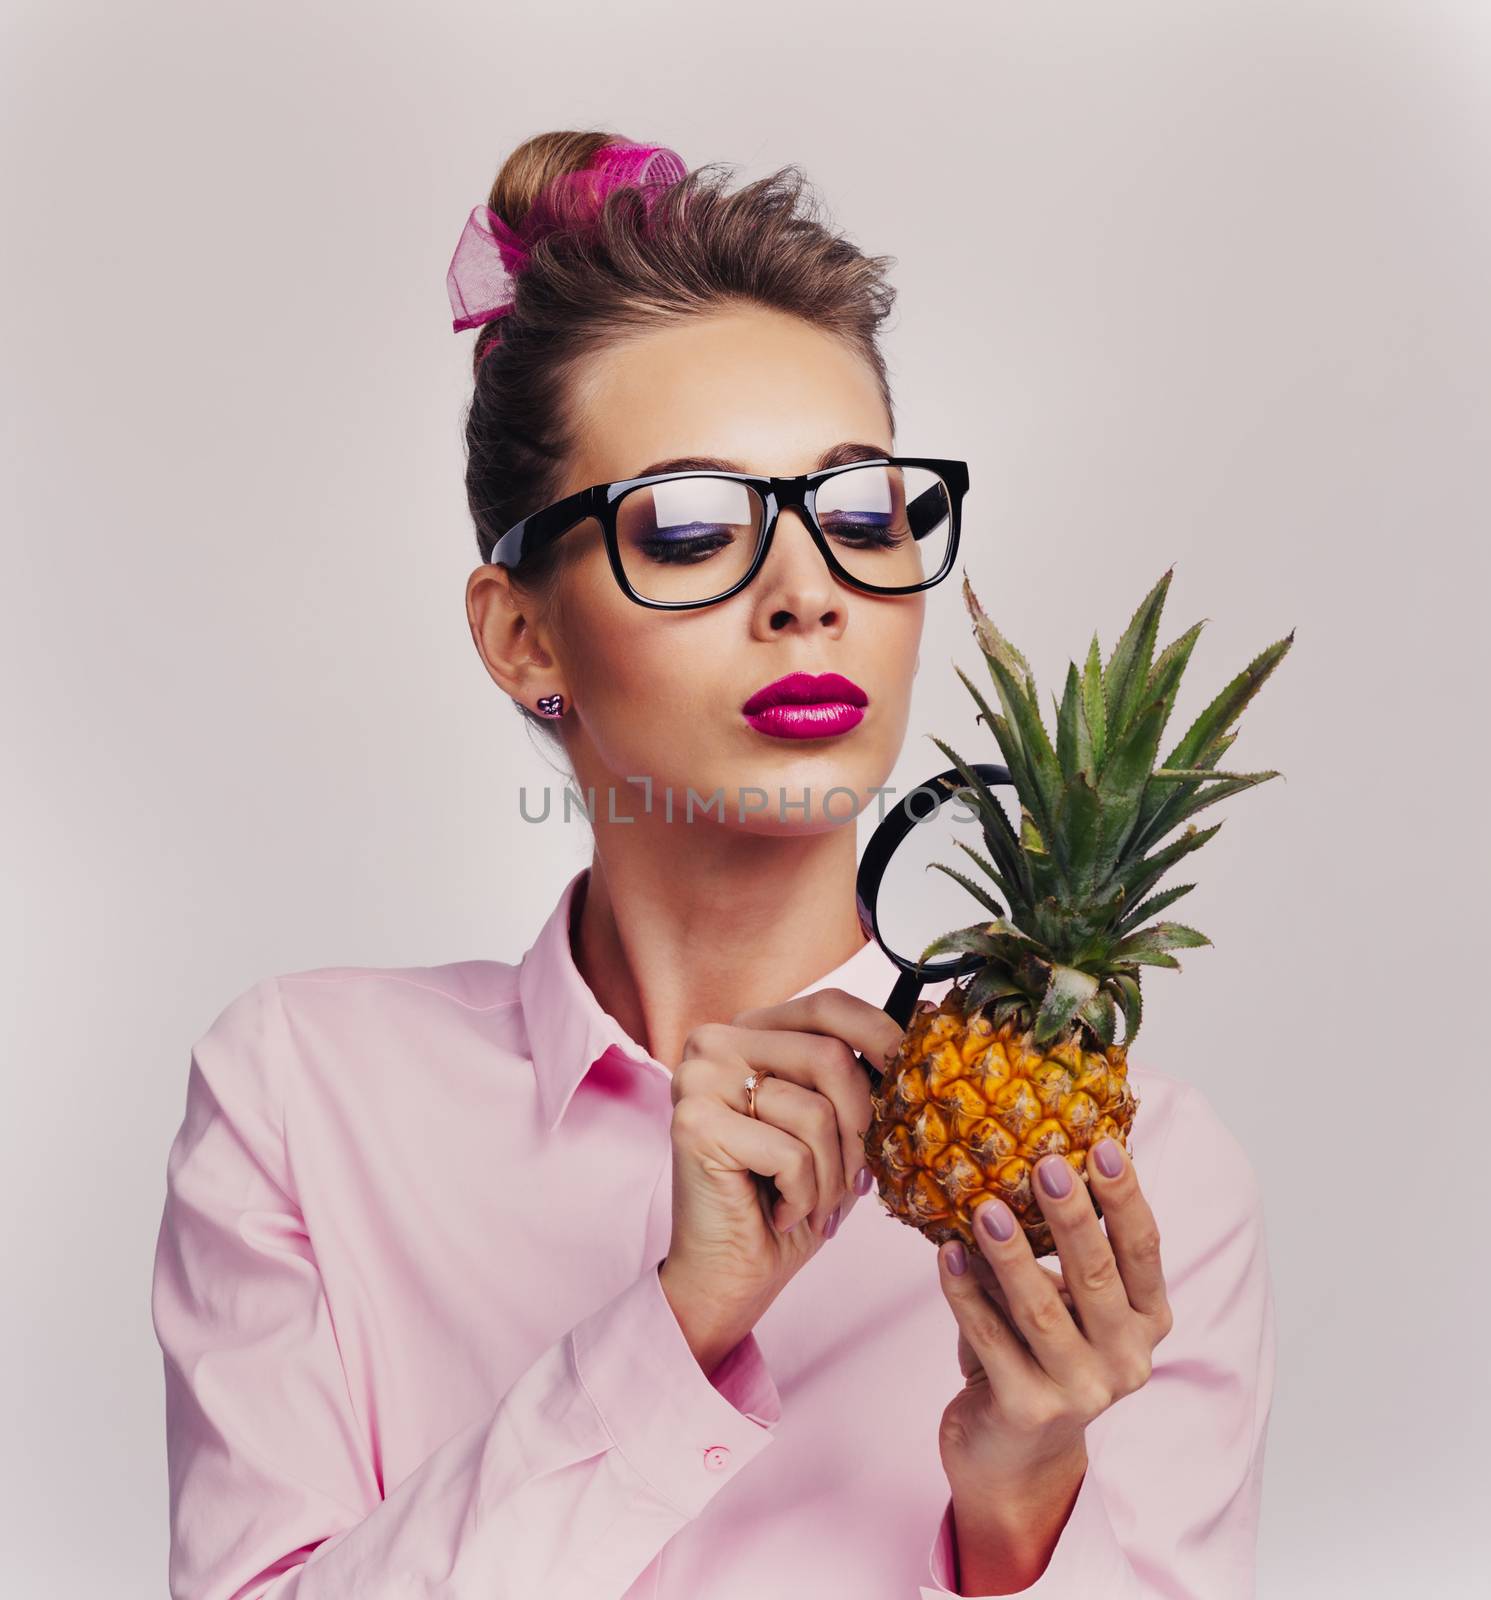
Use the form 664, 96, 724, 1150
923, 568, 1294, 1045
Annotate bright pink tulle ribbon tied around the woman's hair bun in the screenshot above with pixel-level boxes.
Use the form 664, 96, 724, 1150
445, 139, 688, 333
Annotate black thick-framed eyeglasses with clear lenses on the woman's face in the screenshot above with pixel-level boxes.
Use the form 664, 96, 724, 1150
488, 456, 968, 611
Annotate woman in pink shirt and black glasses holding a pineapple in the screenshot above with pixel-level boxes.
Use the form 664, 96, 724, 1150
152, 133, 1273, 1600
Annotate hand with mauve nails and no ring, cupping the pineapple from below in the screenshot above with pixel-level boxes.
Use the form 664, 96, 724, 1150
937, 1144, 1173, 1504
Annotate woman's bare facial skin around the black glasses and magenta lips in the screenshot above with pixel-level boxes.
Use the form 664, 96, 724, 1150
478, 309, 925, 834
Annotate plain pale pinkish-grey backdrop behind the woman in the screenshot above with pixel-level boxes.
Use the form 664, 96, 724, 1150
0, 0, 1491, 1600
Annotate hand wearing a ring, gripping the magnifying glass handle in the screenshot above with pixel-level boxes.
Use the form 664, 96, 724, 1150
659, 989, 902, 1373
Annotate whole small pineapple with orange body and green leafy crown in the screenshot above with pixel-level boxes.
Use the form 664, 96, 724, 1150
864, 571, 1294, 1256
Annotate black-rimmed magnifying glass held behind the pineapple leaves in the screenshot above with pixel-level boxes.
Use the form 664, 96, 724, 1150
854, 762, 1019, 1091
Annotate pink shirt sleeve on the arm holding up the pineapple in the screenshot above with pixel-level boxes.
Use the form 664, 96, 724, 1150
920, 1085, 1277, 1600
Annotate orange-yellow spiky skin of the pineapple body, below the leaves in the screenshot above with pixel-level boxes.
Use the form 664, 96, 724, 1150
864, 984, 1139, 1256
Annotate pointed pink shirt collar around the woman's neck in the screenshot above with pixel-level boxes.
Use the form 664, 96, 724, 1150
518, 867, 897, 1133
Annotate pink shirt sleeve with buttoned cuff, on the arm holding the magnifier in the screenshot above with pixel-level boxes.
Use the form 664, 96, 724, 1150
152, 978, 781, 1600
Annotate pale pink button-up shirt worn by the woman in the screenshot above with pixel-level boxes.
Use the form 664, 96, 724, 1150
152, 869, 1275, 1600
